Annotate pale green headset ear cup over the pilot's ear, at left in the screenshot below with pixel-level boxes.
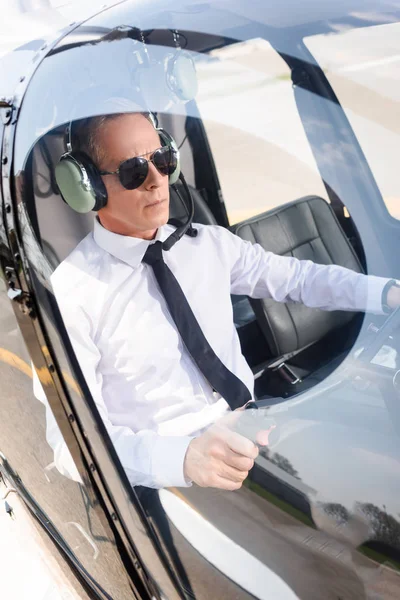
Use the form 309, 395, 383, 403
55, 152, 107, 213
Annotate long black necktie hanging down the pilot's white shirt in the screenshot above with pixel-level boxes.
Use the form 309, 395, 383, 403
143, 242, 251, 410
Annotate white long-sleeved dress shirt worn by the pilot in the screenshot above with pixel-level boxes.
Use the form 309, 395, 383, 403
35, 220, 388, 488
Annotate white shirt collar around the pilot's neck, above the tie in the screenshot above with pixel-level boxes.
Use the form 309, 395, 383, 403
93, 217, 174, 268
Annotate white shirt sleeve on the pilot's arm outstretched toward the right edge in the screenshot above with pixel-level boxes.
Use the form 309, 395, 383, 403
217, 228, 389, 314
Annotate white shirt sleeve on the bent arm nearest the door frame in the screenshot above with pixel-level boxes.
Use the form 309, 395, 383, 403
34, 306, 192, 488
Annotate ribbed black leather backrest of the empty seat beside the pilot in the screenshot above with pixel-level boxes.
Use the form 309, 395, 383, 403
231, 196, 362, 357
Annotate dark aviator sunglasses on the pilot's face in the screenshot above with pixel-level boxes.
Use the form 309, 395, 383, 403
100, 146, 179, 190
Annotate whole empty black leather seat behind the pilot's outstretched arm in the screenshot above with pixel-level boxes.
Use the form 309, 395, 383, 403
231, 196, 362, 395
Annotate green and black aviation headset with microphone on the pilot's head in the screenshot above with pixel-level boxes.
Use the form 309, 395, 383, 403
55, 113, 195, 250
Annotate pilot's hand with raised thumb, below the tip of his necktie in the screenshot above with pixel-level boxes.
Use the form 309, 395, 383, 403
184, 415, 258, 490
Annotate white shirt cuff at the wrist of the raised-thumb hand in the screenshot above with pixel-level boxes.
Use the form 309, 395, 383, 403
151, 435, 193, 488
